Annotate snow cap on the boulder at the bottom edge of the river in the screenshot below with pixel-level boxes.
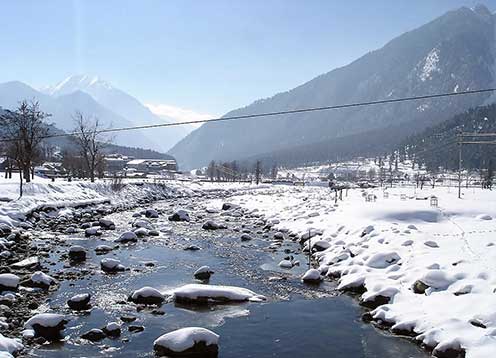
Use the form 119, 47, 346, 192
153, 327, 219, 353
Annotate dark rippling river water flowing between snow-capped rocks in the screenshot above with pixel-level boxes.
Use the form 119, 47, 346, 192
30, 199, 427, 358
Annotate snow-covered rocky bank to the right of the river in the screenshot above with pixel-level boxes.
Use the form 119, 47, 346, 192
207, 187, 496, 358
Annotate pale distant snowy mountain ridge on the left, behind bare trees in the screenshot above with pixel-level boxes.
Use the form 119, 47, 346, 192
0, 75, 187, 152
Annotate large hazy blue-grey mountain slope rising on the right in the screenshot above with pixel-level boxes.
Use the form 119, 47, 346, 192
169, 6, 495, 168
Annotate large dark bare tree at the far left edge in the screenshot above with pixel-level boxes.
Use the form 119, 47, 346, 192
0, 100, 50, 196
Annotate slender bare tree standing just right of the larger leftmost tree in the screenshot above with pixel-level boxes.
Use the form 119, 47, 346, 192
73, 112, 110, 183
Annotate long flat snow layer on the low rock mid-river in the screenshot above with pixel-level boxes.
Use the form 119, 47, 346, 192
172, 284, 266, 302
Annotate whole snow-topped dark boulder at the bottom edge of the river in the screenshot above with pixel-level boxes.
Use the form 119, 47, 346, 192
153, 327, 219, 357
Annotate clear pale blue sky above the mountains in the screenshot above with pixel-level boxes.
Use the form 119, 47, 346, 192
0, 0, 496, 118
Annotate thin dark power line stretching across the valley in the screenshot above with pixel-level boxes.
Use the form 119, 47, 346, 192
0, 88, 496, 142
